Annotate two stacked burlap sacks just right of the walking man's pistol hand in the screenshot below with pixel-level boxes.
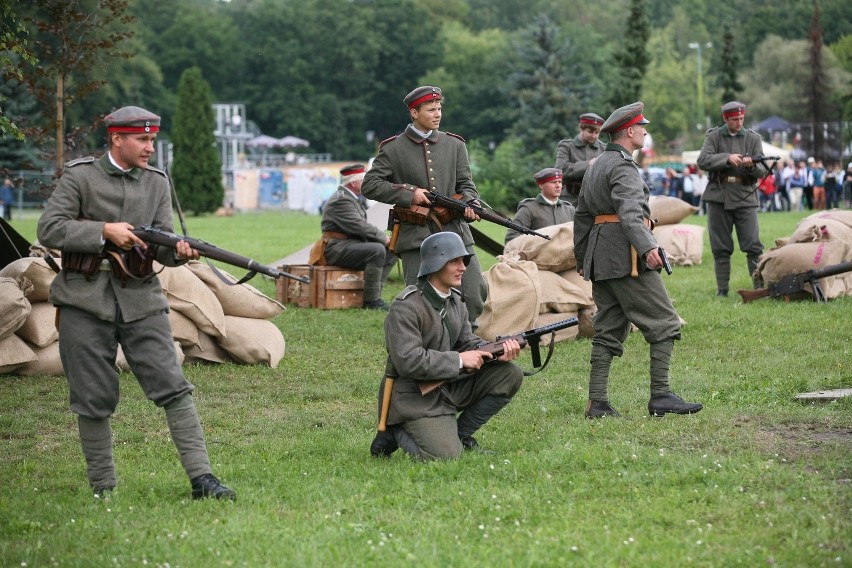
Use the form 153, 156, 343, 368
648, 195, 704, 266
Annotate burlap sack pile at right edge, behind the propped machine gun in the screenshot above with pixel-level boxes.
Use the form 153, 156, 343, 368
755, 209, 852, 299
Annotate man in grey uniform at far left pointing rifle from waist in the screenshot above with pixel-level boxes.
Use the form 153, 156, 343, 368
38, 106, 236, 499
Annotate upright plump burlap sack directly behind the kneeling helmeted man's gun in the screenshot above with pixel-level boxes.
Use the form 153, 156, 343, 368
476, 256, 541, 341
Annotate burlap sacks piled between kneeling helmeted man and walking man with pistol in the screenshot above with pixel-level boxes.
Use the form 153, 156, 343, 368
476, 222, 596, 345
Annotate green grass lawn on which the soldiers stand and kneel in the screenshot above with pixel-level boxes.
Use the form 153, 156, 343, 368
0, 206, 852, 567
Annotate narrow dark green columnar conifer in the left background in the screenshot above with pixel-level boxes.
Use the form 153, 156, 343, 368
170, 67, 225, 215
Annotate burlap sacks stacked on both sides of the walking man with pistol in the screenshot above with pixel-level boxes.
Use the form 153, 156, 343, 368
476, 197, 704, 344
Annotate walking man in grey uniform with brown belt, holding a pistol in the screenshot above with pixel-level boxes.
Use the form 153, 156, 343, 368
574, 102, 702, 418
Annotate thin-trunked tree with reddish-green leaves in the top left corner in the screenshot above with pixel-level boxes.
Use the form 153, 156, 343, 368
17, 0, 133, 173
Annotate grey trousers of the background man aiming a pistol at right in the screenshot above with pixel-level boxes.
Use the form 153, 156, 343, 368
707, 202, 763, 290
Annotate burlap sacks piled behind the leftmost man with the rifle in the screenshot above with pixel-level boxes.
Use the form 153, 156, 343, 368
0, 257, 285, 376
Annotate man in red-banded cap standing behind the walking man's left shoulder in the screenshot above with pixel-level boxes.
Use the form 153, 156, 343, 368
556, 112, 604, 207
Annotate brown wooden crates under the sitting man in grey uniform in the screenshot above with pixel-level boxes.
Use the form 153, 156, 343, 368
275, 264, 364, 310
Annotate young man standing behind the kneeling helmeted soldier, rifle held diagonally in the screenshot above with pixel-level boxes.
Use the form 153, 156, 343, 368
361, 86, 488, 325
